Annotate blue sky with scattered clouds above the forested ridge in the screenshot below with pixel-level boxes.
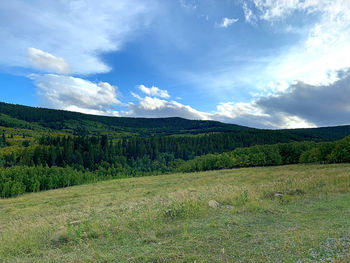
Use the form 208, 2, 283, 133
0, 0, 350, 129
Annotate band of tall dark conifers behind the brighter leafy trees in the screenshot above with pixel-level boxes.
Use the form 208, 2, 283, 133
2, 131, 318, 172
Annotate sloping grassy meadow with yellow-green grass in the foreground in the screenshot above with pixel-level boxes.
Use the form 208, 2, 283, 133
0, 164, 350, 262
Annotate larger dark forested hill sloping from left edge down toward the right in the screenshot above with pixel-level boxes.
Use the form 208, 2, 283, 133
0, 102, 252, 135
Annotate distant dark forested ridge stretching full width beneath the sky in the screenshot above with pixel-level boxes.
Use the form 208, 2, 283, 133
0, 102, 350, 142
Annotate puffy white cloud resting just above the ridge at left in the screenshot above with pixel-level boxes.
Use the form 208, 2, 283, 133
30, 74, 122, 116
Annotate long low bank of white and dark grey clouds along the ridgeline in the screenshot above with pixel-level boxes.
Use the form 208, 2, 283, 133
31, 70, 350, 128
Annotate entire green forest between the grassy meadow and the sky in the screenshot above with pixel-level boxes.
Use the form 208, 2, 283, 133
0, 103, 350, 197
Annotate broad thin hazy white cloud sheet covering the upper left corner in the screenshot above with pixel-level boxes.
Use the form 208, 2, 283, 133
0, 0, 153, 74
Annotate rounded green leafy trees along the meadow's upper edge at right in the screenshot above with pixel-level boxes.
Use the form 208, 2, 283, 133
177, 136, 350, 172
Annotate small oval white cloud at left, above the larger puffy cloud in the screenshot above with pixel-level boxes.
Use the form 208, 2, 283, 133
28, 48, 70, 74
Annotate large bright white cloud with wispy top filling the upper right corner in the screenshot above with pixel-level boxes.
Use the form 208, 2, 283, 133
235, 0, 350, 92
